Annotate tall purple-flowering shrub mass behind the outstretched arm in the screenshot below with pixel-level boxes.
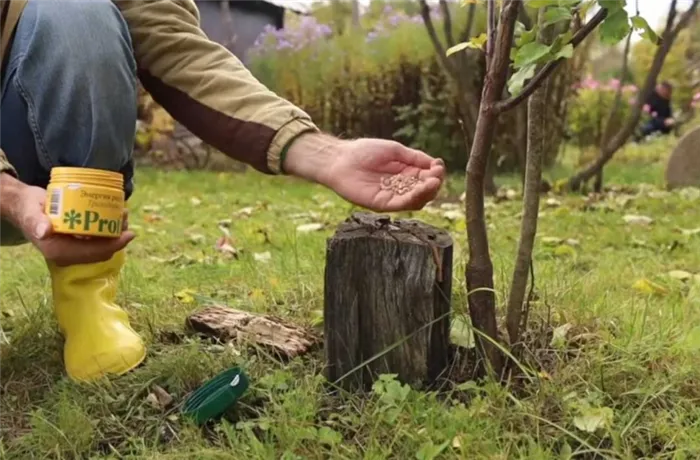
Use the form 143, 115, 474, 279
249, 6, 576, 174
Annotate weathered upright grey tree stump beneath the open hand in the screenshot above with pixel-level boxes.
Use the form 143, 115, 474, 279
324, 213, 453, 390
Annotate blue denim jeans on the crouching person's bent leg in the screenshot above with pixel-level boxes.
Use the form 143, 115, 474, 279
0, 0, 137, 244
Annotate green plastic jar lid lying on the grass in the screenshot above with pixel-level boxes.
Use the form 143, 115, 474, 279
182, 367, 249, 425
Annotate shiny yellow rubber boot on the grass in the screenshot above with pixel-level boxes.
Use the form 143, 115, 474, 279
49, 250, 146, 381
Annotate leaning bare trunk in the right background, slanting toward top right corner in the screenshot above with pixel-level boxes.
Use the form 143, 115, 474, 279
569, 0, 700, 191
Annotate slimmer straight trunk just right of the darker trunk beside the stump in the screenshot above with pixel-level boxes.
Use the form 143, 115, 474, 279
506, 8, 552, 346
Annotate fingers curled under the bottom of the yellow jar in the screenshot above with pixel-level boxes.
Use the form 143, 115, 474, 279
45, 231, 136, 266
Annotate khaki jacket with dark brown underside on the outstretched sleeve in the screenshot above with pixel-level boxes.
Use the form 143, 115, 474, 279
0, 0, 318, 179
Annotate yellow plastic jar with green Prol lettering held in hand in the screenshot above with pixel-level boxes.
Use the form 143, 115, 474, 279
45, 167, 124, 238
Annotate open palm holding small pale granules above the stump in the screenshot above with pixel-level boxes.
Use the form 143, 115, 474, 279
326, 139, 445, 212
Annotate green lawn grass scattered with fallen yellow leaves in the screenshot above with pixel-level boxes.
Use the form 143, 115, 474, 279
0, 132, 700, 459
